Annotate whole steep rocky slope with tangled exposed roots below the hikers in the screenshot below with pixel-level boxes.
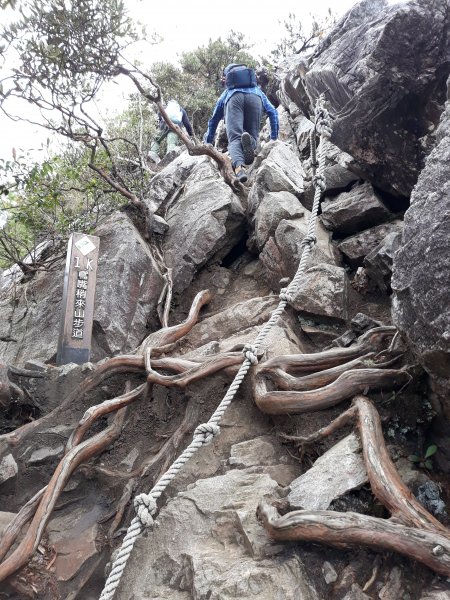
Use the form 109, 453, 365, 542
0, 0, 450, 600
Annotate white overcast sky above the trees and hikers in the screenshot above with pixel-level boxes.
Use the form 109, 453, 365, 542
0, 0, 356, 159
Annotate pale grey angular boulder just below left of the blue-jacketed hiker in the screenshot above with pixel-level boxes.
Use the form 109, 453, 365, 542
163, 162, 245, 293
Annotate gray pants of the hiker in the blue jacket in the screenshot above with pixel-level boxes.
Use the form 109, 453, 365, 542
225, 92, 263, 167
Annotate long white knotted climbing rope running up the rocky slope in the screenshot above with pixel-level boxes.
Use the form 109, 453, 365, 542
100, 98, 331, 600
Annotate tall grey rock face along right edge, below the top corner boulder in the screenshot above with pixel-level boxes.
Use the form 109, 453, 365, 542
391, 91, 450, 404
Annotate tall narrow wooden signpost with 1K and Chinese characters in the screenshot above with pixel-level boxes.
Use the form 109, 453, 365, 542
56, 233, 100, 365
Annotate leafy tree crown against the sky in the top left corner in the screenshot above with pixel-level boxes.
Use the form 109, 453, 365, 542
3, 0, 133, 101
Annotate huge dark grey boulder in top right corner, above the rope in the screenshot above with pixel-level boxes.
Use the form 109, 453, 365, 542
296, 0, 450, 196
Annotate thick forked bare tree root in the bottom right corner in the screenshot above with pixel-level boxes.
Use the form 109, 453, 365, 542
258, 396, 450, 577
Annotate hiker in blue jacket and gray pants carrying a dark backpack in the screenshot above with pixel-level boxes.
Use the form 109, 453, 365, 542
203, 63, 279, 183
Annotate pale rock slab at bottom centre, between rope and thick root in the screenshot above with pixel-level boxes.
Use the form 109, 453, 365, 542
117, 469, 319, 600
